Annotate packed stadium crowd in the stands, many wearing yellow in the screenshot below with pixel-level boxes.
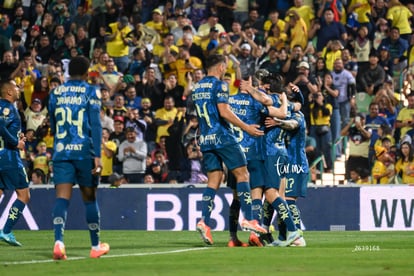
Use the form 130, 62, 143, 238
0, 0, 414, 185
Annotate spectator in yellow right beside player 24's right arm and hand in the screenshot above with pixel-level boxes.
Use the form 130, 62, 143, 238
101, 128, 117, 183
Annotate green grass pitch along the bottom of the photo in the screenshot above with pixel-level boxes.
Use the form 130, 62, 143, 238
0, 230, 414, 276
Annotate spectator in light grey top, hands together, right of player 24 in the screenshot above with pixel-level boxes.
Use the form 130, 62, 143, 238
118, 127, 147, 183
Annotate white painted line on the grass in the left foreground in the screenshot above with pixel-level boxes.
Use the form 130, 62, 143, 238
1, 247, 209, 265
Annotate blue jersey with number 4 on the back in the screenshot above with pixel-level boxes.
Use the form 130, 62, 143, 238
192, 76, 237, 151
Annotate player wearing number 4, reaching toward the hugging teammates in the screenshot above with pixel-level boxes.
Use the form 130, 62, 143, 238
192, 55, 266, 245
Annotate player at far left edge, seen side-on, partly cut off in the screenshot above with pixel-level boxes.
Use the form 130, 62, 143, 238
0, 80, 30, 246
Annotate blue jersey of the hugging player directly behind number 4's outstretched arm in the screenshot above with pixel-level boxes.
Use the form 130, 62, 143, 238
229, 92, 269, 160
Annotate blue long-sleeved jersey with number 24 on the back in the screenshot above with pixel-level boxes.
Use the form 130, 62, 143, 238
49, 80, 102, 161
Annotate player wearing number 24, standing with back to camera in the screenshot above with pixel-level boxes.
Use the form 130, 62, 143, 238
49, 56, 109, 260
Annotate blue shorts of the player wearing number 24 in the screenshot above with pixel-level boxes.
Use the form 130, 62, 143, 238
53, 159, 99, 187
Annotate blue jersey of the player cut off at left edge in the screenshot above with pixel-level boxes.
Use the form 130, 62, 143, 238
0, 99, 24, 170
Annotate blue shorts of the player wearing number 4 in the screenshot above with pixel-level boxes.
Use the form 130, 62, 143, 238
203, 144, 247, 172
